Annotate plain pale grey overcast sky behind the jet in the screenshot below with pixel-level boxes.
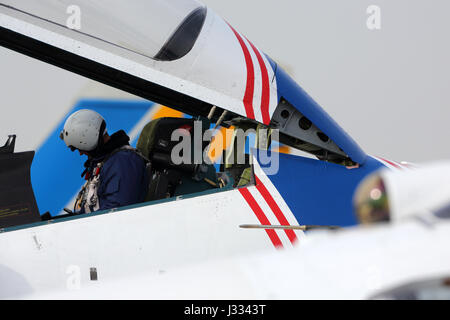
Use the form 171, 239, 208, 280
0, 0, 450, 162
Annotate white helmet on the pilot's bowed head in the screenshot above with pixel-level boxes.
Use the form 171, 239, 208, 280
60, 109, 106, 151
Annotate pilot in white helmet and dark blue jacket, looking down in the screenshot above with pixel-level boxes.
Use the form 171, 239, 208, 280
60, 109, 150, 213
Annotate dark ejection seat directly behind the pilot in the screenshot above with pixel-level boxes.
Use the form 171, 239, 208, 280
136, 117, 220, 201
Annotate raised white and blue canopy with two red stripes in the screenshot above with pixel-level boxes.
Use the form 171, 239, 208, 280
0, 0, 366, 164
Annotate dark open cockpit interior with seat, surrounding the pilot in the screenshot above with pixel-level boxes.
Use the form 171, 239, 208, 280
0, 106, 270, 228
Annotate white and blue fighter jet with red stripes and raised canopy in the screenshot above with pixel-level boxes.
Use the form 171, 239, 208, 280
0, 0, 424, 297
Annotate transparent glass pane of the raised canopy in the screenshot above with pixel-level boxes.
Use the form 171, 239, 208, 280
2, 0, 204, 58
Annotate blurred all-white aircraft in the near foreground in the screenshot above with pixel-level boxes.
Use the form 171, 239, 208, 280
6, 162, 450, 300
